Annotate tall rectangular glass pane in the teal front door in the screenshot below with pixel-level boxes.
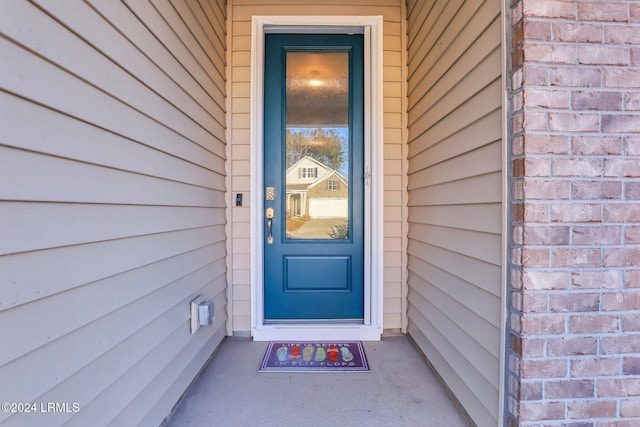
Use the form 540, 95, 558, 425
284, 51, 351, 239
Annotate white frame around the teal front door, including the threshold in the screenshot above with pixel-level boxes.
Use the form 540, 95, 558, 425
250, 16, 384, 341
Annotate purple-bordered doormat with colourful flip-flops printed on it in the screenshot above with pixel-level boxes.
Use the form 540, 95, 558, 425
259, 341, 369, 372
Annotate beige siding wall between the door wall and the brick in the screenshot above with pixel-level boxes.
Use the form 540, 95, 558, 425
407, 0, 503, 426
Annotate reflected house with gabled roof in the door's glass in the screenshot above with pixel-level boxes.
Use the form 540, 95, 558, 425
286, 156, 349, 219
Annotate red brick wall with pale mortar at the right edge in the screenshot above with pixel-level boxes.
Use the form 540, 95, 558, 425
507, 0, 640, 427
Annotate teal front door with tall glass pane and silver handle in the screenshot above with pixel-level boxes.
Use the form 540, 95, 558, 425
264, 34, 364, 323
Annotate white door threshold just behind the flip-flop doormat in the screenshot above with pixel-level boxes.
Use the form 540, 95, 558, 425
252, 323, 382, 341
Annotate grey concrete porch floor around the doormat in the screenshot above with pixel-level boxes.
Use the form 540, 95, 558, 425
165, 336, 470, 427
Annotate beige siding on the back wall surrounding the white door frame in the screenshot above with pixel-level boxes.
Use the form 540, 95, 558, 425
230, 0, 406, 333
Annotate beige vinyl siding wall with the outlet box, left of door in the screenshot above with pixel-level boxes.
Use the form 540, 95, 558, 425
0, 0, 227, 426
